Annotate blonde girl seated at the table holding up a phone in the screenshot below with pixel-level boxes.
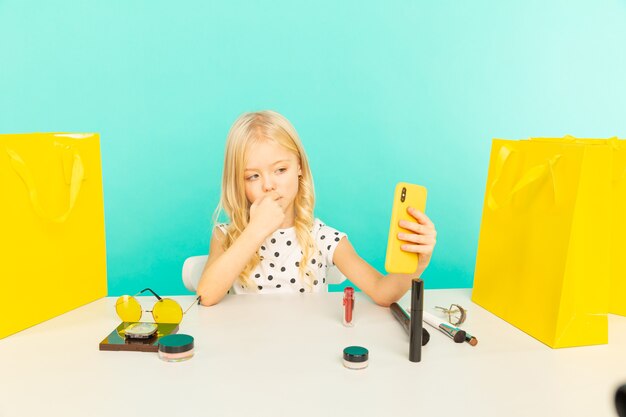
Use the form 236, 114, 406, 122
198, 111, 437, 306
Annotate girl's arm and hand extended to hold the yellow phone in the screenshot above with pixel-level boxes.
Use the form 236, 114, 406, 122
333, 208, 437, 307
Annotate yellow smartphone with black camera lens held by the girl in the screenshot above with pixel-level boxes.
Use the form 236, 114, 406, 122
385, 182, 427, 274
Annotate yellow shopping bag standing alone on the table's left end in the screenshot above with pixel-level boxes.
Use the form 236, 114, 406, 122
0, 133, 107, 338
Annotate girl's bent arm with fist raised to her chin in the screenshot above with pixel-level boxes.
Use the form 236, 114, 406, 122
197, 193, 285, 306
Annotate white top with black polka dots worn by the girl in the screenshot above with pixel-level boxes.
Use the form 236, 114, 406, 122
217, 219, 346, 294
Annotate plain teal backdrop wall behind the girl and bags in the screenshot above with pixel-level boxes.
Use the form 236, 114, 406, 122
0, 0, 626, 295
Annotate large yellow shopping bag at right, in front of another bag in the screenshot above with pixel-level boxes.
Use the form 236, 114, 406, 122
472, 140, 612, 348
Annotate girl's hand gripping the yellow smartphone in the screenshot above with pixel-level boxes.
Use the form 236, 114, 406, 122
398, 207, 437, 275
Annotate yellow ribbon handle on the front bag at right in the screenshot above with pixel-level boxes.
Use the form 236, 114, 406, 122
487, 146, 561, 210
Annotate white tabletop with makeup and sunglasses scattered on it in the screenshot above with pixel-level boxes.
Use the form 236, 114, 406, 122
0, 290, 626, 417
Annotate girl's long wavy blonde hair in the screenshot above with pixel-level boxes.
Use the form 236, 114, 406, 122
214, 110, 315, 289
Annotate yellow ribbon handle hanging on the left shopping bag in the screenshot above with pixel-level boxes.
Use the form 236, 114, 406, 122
6, 144, 85, 223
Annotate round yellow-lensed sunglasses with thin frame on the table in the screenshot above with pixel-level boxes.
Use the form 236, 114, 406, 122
115, 288, 200, 324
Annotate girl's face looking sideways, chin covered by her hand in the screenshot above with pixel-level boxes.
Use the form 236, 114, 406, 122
244, 140, 302, 213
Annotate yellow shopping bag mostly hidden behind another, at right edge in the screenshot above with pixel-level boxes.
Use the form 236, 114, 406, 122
531, 136, 626, 316
